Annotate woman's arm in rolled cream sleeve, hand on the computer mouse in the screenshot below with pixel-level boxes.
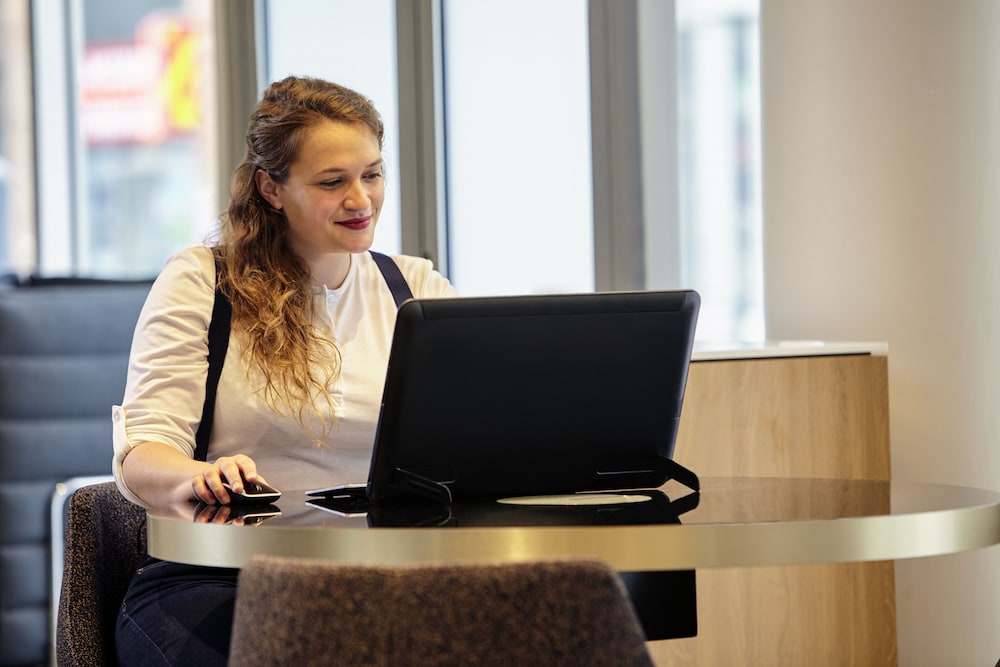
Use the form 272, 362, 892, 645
112, 248, 244, 506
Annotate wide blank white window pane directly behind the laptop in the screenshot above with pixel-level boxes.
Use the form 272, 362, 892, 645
442, 0, 594, 296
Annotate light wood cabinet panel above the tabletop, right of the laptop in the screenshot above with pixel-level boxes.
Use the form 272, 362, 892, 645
674, 355, 890, 480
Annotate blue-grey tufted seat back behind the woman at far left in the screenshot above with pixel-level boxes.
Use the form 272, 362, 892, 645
0, 280, 149, 667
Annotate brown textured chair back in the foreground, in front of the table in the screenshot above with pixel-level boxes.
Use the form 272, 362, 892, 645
229, 556, 653, 667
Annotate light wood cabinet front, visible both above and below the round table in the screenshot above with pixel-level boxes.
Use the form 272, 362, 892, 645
649, 355, 897, 667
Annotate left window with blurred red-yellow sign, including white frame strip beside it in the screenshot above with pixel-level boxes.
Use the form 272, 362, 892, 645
33, 0, 219, 278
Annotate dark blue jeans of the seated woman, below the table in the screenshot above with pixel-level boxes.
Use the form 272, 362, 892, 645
115, 558, 239, 667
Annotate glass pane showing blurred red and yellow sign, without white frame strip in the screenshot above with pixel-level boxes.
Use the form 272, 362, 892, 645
73, 0, 219, 277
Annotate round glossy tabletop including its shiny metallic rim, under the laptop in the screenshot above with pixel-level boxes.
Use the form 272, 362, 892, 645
147, 478, 1000, 571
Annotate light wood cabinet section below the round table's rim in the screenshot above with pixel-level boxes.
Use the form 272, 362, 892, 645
648, 563, 896, 667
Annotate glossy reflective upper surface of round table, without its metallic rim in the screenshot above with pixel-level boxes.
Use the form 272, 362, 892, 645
150, 477, 1000, 527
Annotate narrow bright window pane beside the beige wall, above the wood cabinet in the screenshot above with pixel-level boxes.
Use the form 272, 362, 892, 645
677, 0, 764, 341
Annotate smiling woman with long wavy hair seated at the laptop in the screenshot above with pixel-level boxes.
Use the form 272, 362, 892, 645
113, 77, 454, 665
